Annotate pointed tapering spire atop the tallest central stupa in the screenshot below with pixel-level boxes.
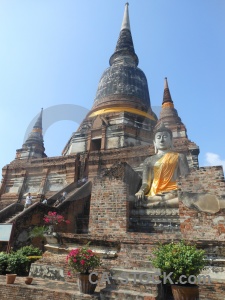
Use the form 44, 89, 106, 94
109, 3, 138, 67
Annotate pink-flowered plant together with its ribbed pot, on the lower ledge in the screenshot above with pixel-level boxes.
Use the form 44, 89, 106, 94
66, 243, 101, 294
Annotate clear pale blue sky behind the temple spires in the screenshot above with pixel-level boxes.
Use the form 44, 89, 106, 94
0, 0, 225, 172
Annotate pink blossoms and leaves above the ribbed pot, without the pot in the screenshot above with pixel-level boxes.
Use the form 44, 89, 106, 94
66, 243, 101, 276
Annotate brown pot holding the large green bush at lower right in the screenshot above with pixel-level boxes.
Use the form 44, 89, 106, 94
172, 284, 199, 300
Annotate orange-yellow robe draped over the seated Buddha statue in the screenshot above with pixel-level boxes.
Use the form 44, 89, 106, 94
146, 152, 179, 196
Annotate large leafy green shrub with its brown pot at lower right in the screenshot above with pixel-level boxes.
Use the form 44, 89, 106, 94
150, 241, 206, 300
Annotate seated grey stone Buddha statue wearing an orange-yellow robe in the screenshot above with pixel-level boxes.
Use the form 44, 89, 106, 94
135, 124, 189, 208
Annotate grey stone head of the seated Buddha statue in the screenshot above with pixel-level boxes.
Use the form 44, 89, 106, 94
153, 123, 173, 150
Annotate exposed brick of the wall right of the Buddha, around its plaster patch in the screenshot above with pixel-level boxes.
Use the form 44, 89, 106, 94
179, 166, 225, 241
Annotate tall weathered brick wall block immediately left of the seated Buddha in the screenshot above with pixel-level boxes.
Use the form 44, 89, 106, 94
89, 162, 140, 236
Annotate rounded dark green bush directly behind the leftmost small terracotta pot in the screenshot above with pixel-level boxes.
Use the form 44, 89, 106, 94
6, 252, 30, 275
